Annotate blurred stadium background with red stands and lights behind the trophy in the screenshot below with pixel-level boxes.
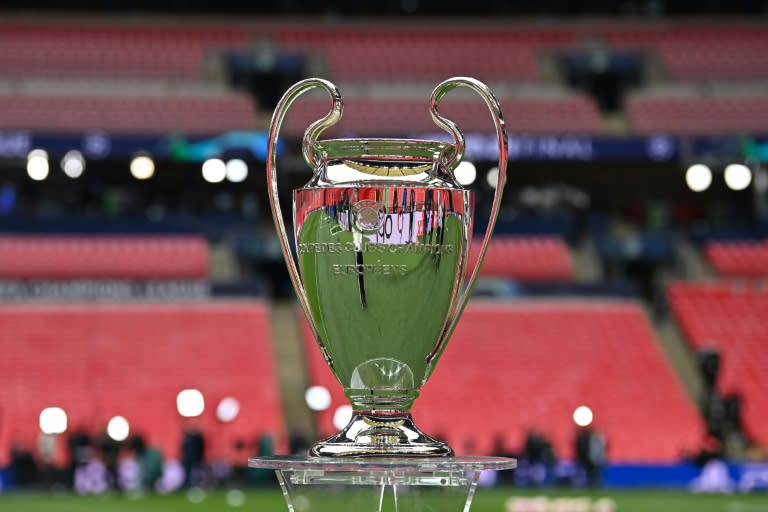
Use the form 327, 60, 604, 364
0, 0, 768, 512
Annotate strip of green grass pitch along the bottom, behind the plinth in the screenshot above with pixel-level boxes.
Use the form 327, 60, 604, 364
0, 489, 768, 512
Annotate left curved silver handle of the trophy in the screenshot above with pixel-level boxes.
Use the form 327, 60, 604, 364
267, 78, 344, 340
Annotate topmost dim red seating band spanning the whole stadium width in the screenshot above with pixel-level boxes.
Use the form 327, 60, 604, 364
0, 20, 768, 82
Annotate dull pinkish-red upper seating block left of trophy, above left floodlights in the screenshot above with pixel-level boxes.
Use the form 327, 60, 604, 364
0, 93, 256, 134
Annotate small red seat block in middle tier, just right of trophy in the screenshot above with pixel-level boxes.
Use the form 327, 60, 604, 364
467, 235, 573, 280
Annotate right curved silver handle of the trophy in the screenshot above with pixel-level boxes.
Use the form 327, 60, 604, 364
427, 77, 509, 362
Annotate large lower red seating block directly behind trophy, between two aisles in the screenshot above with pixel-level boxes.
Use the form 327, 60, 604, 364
304, 301, 703, 462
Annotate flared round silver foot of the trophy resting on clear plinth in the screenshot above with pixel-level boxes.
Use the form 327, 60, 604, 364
309, 412, 453, 457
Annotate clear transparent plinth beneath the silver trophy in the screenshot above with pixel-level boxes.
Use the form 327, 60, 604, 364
248, 456, 516, 512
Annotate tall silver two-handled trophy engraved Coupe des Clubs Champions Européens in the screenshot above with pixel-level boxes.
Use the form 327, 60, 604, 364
267, 77, 507, 457
